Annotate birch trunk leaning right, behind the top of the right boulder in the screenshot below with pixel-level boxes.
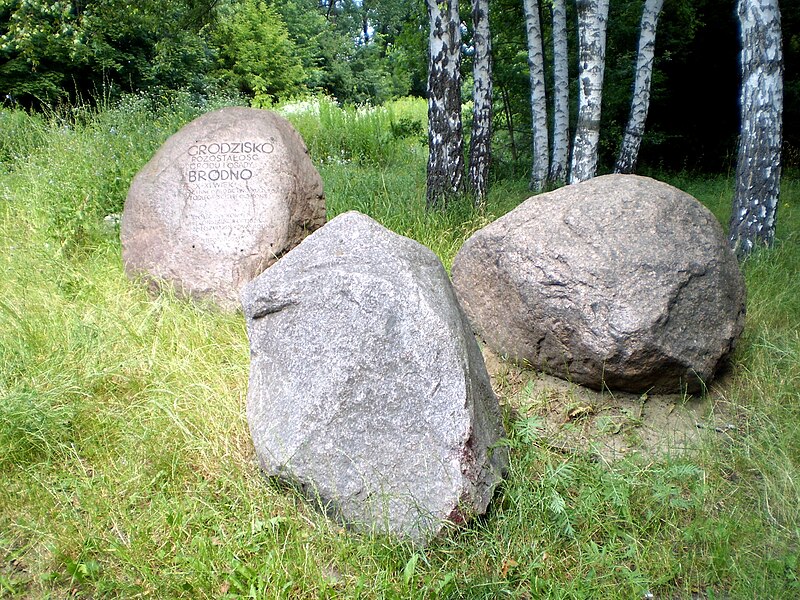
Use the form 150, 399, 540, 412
614, 0, 664, 173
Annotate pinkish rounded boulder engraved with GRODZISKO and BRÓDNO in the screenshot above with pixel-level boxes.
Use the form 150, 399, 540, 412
120, 108, 325, 308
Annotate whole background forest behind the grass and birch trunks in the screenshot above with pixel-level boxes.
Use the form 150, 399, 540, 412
0, 0, 800, 176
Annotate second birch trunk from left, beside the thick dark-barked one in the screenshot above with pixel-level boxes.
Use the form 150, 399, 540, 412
469, 0, 492, 205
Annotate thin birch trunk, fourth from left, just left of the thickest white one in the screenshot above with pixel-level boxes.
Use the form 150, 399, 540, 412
550, 0, 569, 183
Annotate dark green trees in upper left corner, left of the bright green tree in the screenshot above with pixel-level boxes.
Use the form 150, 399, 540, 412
0, 0, 219, 105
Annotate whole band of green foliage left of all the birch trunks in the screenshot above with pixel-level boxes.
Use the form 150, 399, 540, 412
0, 0, 426, 106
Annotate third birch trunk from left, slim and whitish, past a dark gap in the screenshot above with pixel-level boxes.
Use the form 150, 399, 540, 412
522, 0, 550, 192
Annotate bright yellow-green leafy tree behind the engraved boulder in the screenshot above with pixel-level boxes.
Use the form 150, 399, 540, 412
213, 0, 306, 106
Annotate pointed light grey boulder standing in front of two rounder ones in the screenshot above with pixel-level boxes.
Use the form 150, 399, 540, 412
242, 212, 507, 542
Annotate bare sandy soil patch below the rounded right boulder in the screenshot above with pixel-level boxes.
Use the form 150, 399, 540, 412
483, 347, 736, 462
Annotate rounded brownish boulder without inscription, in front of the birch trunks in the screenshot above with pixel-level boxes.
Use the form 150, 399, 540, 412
452, 175, 745, 393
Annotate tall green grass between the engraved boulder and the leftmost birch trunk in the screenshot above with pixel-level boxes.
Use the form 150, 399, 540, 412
277, 98, 496, 267
